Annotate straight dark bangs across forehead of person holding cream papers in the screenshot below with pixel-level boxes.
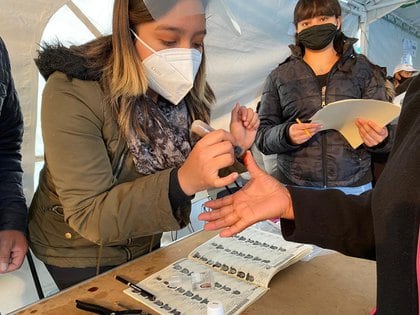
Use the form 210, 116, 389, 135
293, 0, 341, 25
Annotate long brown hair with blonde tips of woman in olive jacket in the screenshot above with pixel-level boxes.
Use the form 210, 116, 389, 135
72, 0, 215, 141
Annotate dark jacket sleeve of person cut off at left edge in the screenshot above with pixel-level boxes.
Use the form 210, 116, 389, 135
0, 38, 27, 232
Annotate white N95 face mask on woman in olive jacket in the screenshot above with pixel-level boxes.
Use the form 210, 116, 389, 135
131, 30, 201, 105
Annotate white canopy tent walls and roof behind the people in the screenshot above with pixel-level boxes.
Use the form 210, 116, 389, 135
0, 0, 420, 312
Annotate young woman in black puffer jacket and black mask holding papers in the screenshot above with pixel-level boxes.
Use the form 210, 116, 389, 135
256, 0, 393, 194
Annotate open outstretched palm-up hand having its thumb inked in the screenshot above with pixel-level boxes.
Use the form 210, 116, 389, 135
198, 151, 294, 237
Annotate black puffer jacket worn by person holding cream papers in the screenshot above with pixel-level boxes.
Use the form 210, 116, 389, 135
256, 39, 394, 187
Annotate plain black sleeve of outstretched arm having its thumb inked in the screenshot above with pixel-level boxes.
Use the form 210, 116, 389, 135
281, 186, 375, 259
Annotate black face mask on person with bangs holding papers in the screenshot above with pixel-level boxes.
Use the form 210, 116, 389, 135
297, 23, 338, 50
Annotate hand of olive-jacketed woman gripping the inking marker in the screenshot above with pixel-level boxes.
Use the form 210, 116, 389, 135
178, 129, 239, 196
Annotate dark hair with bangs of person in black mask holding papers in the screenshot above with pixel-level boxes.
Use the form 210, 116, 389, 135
293, 0, 347, 55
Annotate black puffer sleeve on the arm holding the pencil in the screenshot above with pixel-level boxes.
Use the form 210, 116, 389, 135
255, 73, 299, 154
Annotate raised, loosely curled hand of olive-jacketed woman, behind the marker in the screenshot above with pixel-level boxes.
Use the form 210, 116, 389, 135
230, 103, 260, 151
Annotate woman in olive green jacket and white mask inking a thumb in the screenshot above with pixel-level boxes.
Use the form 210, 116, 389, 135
29, 0, 259, 289
